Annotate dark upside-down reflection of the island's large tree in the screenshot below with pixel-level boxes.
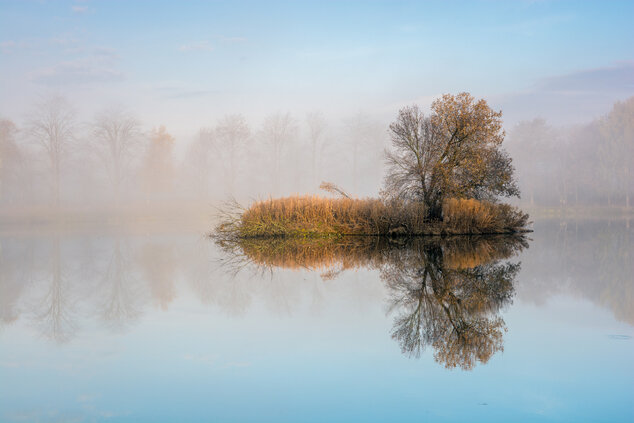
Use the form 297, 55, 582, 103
381, 244, 519, 369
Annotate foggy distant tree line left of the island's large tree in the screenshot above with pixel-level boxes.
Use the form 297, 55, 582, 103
0, 96, 387, 210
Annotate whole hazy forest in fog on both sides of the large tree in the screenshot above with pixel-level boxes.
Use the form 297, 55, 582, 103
0, 96, 634, 218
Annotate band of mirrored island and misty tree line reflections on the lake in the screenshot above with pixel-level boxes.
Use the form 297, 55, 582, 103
0, 220, 634, 369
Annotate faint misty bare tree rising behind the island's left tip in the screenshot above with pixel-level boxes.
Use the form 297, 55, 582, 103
215, 115, 251, 193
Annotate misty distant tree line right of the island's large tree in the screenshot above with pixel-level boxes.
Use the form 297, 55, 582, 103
506, 97, 634, 208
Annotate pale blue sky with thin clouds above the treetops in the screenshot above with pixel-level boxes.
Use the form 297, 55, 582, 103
0, 0, 634, 133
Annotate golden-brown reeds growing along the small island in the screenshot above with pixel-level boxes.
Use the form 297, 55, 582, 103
216, 196, 528, 238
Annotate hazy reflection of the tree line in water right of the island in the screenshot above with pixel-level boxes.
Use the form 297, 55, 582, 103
518, 218, 634, 325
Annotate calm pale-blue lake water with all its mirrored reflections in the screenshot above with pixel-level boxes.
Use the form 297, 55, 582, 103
0, 220, 634, 422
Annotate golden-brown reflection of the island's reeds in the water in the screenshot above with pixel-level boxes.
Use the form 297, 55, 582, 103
224, 235, 526, 270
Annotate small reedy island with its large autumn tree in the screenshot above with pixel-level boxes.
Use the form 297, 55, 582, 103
214, 93, 529, 241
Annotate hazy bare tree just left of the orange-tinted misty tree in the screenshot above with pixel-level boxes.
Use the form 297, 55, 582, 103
92, 109, 141, 201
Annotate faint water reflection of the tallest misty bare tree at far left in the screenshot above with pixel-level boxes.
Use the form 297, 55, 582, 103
35, 235, 77, 343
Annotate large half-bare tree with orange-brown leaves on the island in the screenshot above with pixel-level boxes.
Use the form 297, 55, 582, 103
384, 93, 519, 219
